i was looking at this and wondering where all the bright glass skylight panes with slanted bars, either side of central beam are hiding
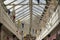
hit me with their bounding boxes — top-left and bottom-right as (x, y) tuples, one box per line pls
(4, 0), (46, 21)
